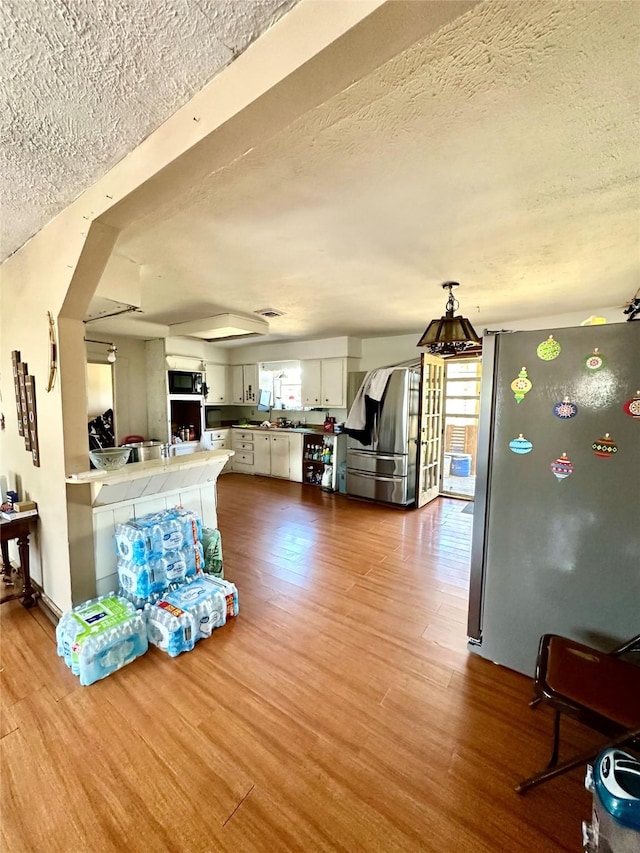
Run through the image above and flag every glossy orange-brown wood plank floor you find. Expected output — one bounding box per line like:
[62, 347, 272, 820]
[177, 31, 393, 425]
[0, 474, 590, 853]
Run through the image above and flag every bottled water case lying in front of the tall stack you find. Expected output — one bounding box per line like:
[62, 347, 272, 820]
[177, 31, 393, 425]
[147, 575, 227, 654]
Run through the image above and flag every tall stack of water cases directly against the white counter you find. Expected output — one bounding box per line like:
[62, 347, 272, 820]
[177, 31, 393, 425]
[115, 507, 204, 607]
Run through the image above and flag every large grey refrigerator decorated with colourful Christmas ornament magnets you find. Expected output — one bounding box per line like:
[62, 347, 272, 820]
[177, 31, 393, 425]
[468, 322, 640, 674]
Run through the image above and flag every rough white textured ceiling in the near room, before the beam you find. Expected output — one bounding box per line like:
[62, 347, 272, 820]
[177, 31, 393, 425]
[0, 0, 297, 259]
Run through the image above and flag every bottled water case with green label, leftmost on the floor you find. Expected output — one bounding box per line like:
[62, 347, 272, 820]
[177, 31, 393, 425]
[56, 595, 148, 686]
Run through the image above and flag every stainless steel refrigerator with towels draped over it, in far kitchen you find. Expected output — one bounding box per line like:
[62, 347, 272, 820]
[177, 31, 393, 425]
[347, 368, 420, 506]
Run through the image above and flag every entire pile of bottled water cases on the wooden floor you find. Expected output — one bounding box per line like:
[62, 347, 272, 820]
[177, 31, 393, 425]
[56, 507, 238, 685]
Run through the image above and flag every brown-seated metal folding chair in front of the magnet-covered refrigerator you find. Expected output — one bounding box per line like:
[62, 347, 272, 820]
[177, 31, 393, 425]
[516, 634, 640, 794]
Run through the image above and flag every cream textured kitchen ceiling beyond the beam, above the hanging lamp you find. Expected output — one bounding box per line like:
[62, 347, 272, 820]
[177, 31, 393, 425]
[99, 2, 640, 339]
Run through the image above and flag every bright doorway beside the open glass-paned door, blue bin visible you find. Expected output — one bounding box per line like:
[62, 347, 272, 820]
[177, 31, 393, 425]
[441, 358, 482, 500]
